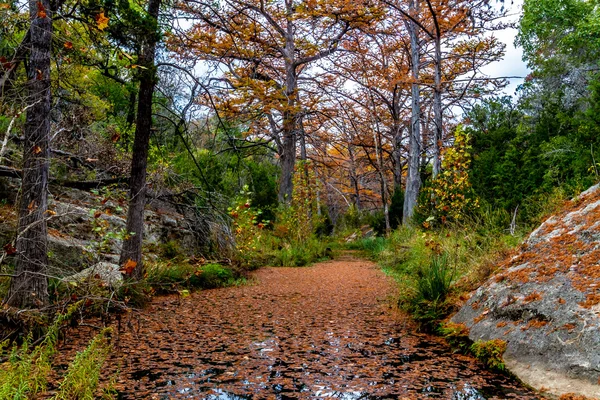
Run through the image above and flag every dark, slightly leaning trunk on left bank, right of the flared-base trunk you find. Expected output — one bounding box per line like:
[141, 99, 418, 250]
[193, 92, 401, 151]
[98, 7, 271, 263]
[119, 0, 161, 279]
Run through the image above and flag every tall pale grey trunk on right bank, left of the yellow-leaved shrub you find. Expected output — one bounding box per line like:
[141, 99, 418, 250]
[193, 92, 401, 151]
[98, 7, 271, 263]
[402, 0, 421, 224]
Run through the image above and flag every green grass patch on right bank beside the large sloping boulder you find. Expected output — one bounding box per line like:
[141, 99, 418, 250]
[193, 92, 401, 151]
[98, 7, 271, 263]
[346, 208, 526, 330]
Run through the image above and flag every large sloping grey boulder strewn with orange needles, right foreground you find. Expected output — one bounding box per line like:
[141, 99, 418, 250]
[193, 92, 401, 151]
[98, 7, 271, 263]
[453, 186, 600, 397]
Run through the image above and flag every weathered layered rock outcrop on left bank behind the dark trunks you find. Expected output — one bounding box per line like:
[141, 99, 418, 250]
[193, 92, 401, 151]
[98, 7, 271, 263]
[0, 178, 225, 277]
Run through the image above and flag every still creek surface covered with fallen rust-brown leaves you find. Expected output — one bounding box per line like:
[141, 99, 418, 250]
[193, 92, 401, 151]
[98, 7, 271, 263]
[50, 255, 540, 400]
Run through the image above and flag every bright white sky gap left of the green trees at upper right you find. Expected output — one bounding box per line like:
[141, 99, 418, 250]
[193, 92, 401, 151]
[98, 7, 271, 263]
[482, 0, 530, 95]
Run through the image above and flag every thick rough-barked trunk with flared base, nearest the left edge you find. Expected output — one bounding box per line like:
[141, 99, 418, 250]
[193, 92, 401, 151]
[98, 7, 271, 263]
[6, 0, 52, 308]
